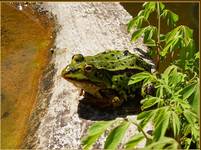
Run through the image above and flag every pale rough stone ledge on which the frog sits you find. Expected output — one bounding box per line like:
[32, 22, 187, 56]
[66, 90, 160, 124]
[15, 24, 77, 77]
[23, 2, 152, 149]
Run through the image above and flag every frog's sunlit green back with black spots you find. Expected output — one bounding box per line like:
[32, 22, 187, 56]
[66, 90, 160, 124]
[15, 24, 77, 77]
[86, 50, 151, 71]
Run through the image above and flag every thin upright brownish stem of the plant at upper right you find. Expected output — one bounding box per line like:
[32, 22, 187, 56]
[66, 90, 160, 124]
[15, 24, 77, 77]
[156, 2, 161, 70]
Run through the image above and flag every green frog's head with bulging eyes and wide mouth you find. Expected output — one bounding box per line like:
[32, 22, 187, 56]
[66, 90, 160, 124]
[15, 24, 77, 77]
[62, 54, 109, 96]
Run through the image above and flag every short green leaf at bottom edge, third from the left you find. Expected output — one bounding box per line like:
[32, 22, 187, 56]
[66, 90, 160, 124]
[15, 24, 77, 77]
[125, 133, 144, 149]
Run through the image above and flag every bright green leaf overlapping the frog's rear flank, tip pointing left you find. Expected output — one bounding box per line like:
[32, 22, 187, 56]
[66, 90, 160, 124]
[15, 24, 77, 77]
[128, 71, 151, 85]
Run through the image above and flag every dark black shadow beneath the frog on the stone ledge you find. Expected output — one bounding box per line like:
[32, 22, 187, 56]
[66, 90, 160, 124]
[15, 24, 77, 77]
[78, 98, 141, 121]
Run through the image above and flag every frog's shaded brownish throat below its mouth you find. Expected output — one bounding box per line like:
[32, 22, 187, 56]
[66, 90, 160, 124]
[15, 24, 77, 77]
[66, 78, 103, 99]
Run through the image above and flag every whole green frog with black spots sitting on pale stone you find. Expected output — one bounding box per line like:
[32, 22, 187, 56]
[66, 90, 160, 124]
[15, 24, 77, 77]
[61, 50, 151, 108]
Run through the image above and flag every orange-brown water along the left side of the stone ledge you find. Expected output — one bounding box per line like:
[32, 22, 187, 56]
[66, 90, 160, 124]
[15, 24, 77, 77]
[1, 3, 54, 149]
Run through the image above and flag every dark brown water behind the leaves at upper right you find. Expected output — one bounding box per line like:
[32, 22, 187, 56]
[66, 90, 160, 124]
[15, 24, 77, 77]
[121, 2, 199, 70]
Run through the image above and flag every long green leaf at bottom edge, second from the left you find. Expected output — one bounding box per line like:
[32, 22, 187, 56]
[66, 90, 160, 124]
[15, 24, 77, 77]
[104, 121, 130, 149]
